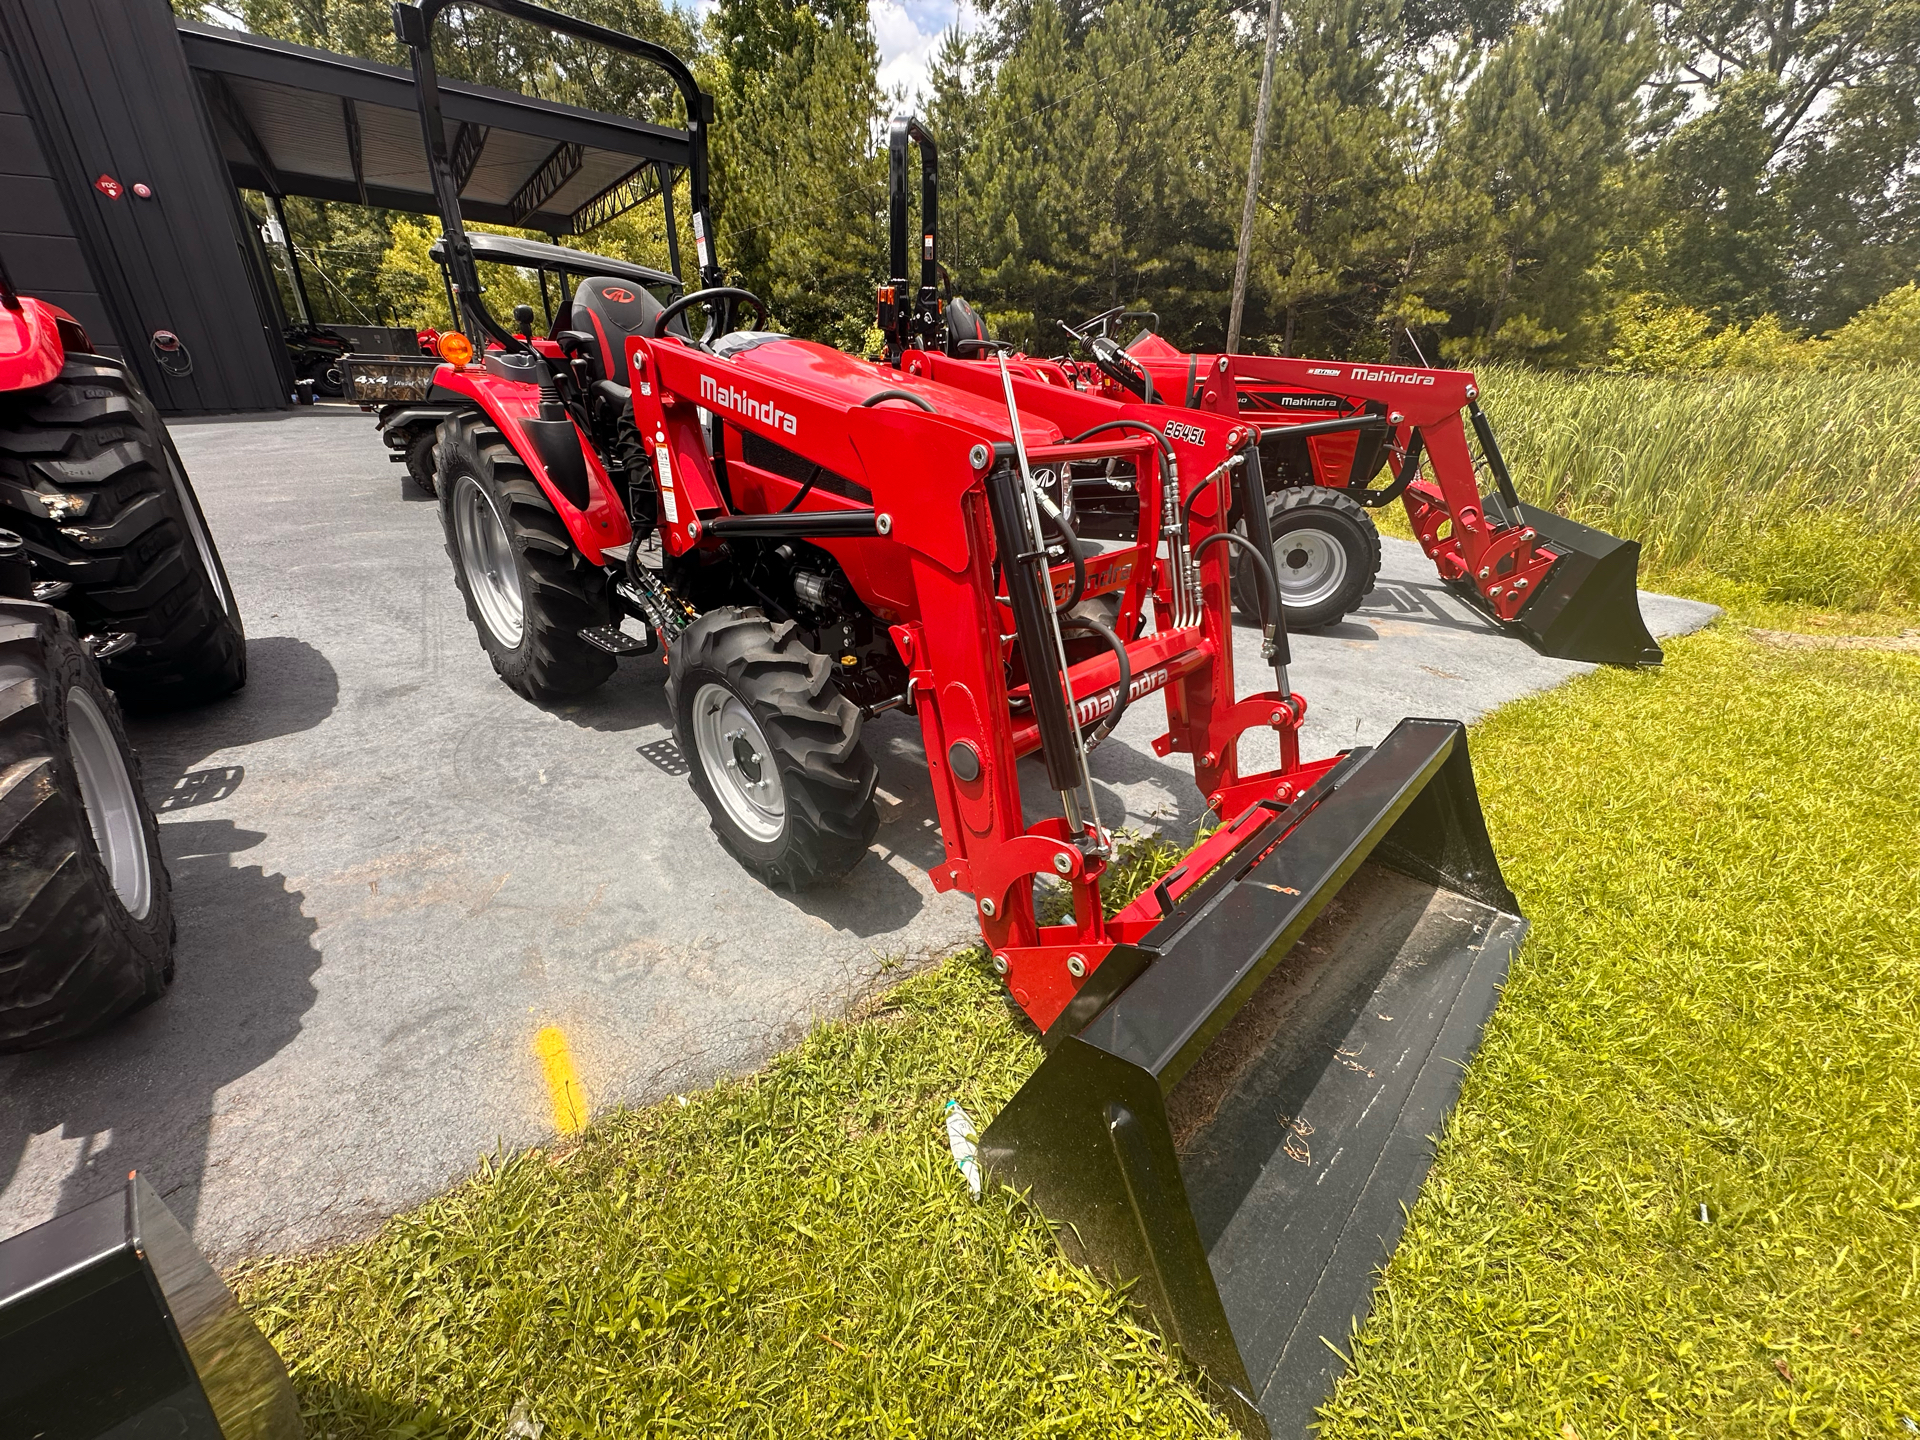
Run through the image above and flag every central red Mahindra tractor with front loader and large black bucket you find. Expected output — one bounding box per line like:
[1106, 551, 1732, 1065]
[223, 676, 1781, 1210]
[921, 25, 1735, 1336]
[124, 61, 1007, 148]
[394, 0, 1524, 1434]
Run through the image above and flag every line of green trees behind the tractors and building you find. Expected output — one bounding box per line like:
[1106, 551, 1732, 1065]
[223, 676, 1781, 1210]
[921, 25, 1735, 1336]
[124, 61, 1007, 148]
[182, 0, 1920, 367]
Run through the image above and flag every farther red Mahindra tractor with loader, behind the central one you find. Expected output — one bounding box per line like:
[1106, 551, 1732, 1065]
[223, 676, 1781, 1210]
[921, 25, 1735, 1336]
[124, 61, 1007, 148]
[879, 115, 1661, 666]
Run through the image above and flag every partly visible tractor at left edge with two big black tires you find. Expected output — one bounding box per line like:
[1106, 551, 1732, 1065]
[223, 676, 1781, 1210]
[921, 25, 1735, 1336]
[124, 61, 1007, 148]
[0, 253, 246, 1050]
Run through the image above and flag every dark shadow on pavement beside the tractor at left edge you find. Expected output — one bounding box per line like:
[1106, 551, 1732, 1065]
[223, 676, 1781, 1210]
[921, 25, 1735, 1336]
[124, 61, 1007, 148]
[0, 637, 338, 1235]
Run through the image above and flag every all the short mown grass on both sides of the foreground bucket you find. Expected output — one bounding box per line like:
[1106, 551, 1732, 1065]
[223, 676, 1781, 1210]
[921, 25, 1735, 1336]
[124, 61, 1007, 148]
[236, 628, 1920, 1440]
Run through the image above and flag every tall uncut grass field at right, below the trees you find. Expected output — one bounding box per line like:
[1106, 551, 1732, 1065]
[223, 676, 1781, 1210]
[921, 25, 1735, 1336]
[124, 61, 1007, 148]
[1478, 367, 1920, 609]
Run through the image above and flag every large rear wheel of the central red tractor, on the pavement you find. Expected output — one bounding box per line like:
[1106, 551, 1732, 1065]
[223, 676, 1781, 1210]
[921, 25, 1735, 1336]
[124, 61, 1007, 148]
[434, 411, 616, 701]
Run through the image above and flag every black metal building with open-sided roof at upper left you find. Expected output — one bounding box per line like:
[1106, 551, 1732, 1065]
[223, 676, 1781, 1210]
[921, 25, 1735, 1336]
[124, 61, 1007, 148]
[0, 0, 687, 415]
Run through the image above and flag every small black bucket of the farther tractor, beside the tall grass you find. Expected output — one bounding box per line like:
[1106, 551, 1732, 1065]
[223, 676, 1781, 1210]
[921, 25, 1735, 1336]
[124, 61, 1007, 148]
[1455, 495, 1663, 666]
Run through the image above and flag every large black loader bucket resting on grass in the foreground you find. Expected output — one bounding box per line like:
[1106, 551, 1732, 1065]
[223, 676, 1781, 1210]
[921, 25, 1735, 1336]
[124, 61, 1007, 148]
[981, 720, 1526, 1436]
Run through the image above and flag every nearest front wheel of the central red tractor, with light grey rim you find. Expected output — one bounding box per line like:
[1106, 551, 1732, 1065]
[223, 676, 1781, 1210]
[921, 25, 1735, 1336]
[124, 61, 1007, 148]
[666, 605, 879, 891]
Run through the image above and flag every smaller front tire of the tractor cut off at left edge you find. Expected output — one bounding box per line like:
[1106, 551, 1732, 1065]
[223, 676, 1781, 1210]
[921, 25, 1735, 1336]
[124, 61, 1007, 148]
[0, 599, 173, 1052]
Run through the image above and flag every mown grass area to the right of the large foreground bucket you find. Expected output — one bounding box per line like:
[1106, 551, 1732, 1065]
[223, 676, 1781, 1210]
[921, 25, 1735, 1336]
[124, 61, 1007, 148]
[1329, 632, 1920, 1440]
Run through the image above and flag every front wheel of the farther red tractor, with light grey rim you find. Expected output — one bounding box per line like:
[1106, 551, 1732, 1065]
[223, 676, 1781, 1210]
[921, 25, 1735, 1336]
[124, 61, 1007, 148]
[1233, 486, 1380, 630]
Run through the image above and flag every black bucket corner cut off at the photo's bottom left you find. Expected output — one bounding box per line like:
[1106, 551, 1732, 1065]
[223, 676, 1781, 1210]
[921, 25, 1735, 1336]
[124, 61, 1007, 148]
[0, 1175, 301, 1440]
